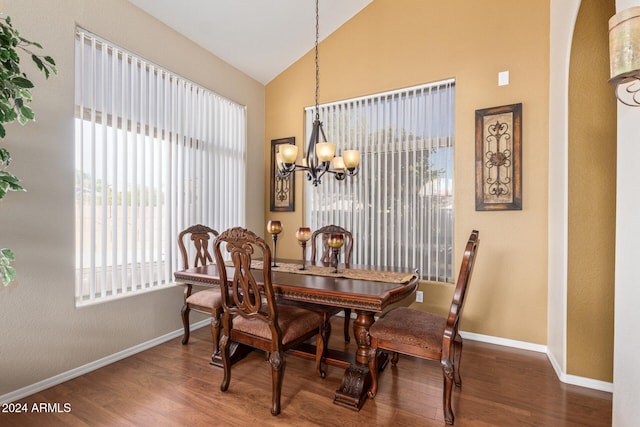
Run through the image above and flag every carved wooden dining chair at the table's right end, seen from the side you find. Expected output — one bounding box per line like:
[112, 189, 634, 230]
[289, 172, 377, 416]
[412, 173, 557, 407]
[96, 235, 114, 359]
[368, 230, 479, 424]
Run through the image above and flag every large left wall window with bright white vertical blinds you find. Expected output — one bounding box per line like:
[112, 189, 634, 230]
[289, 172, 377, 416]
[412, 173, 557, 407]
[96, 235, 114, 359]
[75, 29, 246, 305]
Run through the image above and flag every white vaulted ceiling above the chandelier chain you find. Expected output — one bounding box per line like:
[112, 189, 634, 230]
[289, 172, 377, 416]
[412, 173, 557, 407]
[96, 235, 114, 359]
[129, 0, 373, 84]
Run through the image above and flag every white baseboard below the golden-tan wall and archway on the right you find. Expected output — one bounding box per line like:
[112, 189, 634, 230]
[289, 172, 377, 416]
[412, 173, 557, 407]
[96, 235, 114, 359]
[460, 331, 613, 393]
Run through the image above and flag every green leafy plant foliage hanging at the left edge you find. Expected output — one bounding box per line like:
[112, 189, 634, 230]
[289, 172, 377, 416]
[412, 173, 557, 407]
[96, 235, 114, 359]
[0, 16, 57, 286]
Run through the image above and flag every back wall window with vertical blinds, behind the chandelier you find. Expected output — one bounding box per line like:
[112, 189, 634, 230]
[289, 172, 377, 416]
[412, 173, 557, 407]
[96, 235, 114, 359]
[306, 80, 455, 282]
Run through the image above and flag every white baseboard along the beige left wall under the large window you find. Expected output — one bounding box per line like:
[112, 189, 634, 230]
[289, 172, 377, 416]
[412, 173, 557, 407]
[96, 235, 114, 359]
[0, 319, 211, 405]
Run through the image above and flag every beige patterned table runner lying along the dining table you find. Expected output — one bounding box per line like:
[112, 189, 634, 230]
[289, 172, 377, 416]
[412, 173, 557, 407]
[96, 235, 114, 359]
[225, 260, 416, 283]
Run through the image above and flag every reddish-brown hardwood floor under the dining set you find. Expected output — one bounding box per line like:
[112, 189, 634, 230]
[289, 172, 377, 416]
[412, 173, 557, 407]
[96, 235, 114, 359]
[0, 318, 611, 427]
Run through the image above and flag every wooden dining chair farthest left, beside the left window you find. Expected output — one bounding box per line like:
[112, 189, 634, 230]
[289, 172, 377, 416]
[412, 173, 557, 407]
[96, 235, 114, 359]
[178, 224, 222, 354]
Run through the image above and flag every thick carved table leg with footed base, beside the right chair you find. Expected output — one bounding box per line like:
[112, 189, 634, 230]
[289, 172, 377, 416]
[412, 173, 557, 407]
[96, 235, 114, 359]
[333, 310, 384, 411]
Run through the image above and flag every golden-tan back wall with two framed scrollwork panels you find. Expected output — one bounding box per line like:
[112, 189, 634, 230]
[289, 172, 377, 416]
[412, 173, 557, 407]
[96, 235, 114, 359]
[263, 0, 549, 344]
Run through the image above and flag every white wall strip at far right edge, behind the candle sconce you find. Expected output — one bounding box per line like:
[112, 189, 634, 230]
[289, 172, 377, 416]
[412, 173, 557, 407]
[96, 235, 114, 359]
[612, 0, 640, 427]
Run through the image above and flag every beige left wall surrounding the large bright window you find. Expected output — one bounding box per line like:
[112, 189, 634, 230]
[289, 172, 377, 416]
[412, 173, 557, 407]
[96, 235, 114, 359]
[0, 0, 265, 396]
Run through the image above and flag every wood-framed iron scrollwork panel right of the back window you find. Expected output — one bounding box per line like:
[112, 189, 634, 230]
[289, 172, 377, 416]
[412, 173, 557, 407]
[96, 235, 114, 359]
[475, 103, 522, 211]
